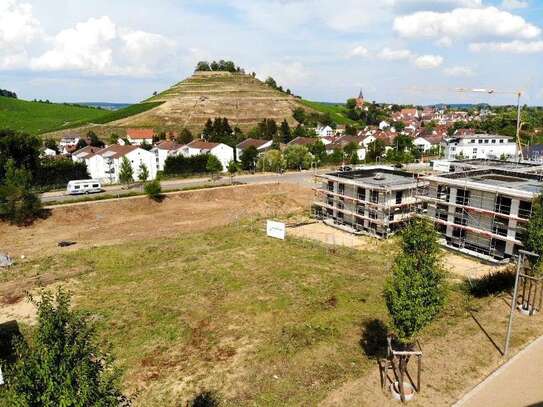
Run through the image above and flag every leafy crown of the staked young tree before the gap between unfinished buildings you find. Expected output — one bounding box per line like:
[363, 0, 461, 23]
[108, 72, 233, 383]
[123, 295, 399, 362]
[384, 219, 446, 345]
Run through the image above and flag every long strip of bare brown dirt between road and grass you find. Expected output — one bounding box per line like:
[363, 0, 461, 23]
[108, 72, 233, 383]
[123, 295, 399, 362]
[0, 184, 312, 259]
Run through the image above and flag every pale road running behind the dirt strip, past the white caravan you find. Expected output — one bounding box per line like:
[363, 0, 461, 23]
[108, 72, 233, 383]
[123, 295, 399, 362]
[41, 171, 314, 202]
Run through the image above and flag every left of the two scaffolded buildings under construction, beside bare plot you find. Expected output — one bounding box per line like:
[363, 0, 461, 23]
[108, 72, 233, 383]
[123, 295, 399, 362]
[313, 167, 427, 238]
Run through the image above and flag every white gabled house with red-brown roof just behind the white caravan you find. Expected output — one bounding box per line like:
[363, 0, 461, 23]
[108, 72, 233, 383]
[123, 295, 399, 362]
[72, 144, 157, 184]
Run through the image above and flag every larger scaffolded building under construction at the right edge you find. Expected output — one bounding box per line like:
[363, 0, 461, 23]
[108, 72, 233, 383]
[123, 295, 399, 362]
[421, 167, 543, 260]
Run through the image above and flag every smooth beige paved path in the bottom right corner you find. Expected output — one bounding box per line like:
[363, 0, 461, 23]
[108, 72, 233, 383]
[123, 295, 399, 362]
[454, 337, 543, 407]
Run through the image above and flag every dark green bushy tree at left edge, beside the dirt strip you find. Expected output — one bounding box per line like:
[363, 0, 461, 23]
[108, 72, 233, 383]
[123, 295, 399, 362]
[0, 159, 42, 225]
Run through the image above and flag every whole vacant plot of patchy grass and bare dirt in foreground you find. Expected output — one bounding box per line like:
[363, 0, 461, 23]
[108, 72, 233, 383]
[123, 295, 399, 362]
[0, 185, 543, 406]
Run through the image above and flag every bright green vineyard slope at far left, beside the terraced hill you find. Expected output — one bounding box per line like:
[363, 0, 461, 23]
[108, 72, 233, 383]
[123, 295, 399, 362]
[0, 96, 111, 134]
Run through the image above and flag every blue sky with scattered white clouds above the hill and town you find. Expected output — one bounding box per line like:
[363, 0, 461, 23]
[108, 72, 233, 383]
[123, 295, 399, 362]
[0, 0, 543, 105]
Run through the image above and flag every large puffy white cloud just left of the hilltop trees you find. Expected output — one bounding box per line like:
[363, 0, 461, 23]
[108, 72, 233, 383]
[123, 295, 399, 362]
[31, 16, 173, 76]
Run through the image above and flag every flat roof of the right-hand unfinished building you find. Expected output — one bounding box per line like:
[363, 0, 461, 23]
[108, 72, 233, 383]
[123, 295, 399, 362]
[426, 168, 543, 196]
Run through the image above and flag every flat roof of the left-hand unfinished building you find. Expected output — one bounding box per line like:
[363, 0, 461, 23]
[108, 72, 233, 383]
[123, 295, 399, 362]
[326, 168, 417, 188]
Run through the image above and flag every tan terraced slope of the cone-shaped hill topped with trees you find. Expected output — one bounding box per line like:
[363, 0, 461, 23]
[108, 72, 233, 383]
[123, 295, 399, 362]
[103, 72, 311, 131]
